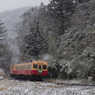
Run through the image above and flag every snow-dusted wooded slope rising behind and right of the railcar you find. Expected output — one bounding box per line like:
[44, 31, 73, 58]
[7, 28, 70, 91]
[0, 0, 95, 79]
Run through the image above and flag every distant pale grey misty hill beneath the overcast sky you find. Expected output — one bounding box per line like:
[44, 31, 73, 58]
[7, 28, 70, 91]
[0, 7, 30, 39]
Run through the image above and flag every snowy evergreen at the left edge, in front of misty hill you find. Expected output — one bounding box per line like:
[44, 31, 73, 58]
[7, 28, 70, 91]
[0, 20, 11, 70]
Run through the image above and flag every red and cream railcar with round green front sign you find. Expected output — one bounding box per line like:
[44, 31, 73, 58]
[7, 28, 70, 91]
[10, 61, 48, 79]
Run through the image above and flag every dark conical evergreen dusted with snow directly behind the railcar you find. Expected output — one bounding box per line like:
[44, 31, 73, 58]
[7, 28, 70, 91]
[22, 22, 46, 56]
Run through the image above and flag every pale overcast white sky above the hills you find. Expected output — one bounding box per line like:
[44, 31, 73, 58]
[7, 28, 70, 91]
[0, 0, 49, 12]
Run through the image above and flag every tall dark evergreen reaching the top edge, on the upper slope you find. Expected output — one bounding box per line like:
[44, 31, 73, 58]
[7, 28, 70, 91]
[47, 0, 75, 34]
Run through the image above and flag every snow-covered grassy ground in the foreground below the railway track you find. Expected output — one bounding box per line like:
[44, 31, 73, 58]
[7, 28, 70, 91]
[0, 79, 95, 95]
